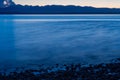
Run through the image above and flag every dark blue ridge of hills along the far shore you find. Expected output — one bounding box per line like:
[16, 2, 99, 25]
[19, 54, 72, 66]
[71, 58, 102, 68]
[0, 5, 120, 14]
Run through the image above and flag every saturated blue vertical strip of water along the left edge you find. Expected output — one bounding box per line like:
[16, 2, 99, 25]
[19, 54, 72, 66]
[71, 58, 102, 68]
[0, 15, 15, 61]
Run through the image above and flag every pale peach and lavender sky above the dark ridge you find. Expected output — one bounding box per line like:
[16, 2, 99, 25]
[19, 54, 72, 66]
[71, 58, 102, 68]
[13, 0, 120, 8]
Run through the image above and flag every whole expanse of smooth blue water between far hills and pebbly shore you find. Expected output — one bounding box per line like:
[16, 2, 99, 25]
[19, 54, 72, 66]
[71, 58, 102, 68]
[0, 15, 120, 64]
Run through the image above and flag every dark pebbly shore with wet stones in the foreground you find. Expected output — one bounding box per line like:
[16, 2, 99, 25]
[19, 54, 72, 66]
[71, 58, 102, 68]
[0, 59, 120, 80]
